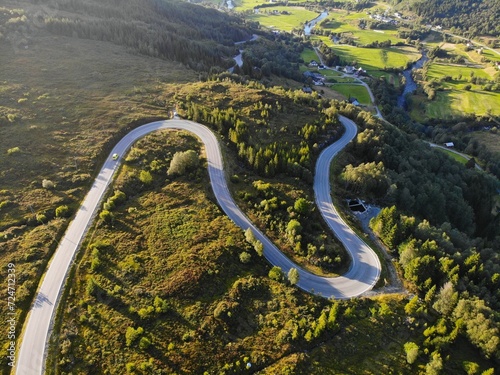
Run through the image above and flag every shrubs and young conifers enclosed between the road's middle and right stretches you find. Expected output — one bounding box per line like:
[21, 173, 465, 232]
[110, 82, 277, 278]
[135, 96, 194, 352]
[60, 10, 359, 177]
[165, 77, 348, 273]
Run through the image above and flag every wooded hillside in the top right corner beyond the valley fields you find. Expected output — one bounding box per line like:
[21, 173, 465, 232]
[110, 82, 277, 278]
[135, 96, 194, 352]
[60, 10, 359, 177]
[386, 0, 500, 37]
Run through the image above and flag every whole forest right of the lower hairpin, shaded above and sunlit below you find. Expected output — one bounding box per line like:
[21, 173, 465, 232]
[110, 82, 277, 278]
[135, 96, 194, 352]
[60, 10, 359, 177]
[334, 108, 500, 369]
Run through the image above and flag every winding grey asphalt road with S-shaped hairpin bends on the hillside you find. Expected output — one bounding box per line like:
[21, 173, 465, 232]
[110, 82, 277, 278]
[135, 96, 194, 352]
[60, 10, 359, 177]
[16, 117, 380, 375]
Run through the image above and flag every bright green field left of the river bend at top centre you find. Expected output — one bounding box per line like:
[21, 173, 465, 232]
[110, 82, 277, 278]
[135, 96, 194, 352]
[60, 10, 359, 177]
[246, 6, 319, 32]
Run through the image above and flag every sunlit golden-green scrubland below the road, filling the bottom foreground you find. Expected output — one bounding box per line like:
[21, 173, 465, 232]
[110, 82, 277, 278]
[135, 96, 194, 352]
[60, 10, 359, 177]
[48, 131, 495, 374]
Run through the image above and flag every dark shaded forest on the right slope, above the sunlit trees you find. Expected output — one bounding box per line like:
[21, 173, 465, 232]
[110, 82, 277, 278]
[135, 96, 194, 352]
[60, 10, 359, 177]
[344, 110, 498, 238]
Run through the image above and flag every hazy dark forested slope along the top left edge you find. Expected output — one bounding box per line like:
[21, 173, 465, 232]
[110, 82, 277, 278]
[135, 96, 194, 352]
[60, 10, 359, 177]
[39, 0, 252, 71]
